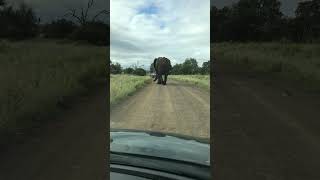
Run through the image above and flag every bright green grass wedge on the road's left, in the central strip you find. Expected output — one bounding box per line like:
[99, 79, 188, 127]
[110, 75, 151, 105]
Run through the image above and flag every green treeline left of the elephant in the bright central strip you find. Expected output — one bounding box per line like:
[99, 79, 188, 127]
[110, 60, 147, 76]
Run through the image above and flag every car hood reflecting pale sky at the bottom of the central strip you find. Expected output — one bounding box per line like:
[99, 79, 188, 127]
[110, 129, 210, 166]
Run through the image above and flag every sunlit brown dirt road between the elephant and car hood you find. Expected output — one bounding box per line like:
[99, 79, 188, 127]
[110, 80, 210, 137]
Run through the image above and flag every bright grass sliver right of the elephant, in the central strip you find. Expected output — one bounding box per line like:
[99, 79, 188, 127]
[169, 75, 210, 91]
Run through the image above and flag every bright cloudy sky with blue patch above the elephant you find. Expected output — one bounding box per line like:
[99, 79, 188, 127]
[110, 0, 210, 69]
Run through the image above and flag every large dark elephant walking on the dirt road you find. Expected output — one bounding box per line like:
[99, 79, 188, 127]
[153, 57, 172, 85]
